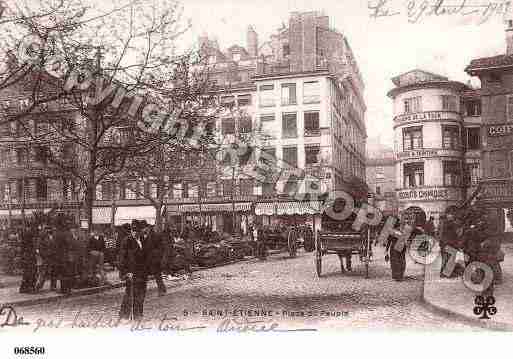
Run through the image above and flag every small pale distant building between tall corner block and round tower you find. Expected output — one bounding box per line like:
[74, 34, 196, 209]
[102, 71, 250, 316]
[365, 146, 398, 215]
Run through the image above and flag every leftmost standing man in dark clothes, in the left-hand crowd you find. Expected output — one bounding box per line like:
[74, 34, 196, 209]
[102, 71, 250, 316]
[20, 223, 37, 293]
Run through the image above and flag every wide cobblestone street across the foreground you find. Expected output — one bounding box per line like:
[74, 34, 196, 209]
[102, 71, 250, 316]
[5, 248, 484, 332]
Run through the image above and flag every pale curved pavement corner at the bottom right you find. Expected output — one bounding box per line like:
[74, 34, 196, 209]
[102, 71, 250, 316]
[423, 243, 513, 331]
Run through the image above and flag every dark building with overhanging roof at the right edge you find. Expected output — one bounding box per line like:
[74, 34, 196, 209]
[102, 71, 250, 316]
[465, 20, 513, 233]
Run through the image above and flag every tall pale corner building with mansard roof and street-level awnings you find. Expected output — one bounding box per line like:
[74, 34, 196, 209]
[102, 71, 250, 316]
[162, 12, 367, 230]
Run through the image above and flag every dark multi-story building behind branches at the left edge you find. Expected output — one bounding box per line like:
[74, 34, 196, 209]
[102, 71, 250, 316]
[0, 81, 79, 229]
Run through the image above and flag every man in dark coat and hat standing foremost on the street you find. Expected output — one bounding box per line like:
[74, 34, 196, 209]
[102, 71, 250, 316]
[119, 220, 151, 320]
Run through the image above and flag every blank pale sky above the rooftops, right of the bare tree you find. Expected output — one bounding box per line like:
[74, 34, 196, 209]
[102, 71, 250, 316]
[178, 0, 511, 145]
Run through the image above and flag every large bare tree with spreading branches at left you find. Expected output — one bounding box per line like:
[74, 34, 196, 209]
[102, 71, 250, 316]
[0, 0, 203, 226]
